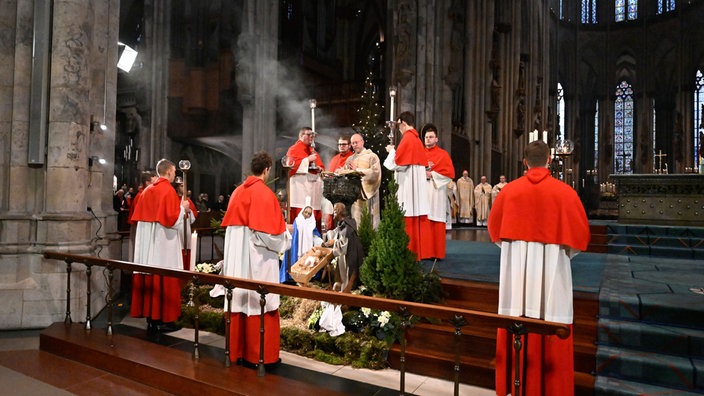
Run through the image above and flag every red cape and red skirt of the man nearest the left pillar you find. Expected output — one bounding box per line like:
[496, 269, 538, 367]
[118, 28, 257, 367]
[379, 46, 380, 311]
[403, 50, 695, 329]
[130, 178, 181, 323]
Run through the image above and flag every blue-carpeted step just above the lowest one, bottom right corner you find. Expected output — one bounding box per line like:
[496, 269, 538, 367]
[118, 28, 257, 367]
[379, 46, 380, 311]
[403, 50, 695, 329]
[596, 346, 704, 394]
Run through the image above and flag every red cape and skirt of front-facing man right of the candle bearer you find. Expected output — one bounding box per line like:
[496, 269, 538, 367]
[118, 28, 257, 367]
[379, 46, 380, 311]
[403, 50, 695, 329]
[422, 146, 455, 259]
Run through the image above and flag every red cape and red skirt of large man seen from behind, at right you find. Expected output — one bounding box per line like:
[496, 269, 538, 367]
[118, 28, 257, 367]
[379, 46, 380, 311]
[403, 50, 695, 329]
[488, 168, 590, 396]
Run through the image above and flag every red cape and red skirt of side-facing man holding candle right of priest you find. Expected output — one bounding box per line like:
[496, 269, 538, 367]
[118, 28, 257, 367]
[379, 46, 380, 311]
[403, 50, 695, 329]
[394, 128, 430, 260]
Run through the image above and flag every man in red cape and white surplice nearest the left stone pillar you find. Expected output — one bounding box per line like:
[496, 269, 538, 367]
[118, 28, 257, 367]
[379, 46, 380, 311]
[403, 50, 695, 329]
[130, 159, 190, 332]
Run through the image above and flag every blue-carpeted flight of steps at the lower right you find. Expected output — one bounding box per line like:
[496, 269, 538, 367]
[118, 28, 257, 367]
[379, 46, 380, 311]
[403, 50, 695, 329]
[595, 226, 704, 395]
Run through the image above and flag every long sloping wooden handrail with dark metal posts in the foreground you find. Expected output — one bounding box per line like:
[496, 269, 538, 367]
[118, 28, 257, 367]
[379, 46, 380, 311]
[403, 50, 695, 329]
[44, 251, 570, 395]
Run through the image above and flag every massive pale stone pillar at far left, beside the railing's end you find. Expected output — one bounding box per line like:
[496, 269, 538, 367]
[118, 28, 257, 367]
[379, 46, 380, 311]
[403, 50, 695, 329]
[0, 0, 119, 329]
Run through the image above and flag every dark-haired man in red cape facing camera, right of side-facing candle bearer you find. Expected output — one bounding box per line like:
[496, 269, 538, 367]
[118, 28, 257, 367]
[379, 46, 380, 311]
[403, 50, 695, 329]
[422, 124, 455, 259]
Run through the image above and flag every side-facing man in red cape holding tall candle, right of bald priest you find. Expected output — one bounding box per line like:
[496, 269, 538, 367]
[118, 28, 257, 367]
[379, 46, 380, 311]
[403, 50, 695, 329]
[384, 111, 430, 260]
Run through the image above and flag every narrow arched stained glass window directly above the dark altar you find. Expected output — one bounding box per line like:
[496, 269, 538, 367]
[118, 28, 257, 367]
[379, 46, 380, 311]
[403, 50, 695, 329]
[614, 81, 634, 174]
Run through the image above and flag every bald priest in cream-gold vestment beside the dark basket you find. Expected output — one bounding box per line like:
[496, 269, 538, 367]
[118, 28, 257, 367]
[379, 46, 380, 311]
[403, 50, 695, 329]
[345, 133, 381, 230]
